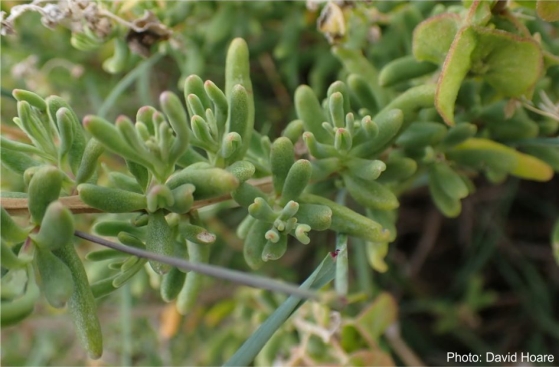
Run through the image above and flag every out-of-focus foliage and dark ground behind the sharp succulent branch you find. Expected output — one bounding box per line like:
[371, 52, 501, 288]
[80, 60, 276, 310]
[0, 0, 559, 366]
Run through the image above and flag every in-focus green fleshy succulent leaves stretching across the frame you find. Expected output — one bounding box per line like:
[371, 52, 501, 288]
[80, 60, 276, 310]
[1, 1, 559, 357]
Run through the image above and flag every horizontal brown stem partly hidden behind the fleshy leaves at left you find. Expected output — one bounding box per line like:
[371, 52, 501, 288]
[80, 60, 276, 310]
[0, 177, 272, 215]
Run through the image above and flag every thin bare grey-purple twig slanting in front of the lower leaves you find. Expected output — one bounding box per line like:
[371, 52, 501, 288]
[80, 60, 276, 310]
[74, 231, 318, 300]
